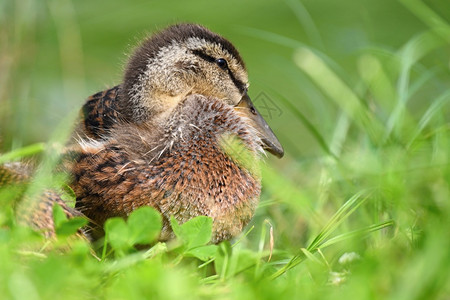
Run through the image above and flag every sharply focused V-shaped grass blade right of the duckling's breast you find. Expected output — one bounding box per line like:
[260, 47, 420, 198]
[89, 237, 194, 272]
[270, 191, 393, 279]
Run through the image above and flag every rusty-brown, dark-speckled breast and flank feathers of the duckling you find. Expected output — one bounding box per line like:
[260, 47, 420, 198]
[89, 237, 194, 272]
[72, 138, 261, 242]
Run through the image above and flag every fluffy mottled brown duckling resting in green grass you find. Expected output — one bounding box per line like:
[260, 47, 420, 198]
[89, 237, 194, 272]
[66, 24, 283, 242]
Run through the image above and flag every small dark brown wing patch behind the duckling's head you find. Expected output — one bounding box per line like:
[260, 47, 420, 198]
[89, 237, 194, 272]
[75, 85, 121, 140]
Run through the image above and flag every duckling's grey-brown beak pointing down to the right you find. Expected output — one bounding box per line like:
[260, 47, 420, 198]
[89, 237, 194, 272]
[235, 93, 284, 158]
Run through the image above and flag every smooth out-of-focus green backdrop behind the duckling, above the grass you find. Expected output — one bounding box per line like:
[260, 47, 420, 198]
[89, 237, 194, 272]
[0, 0, 450, 157]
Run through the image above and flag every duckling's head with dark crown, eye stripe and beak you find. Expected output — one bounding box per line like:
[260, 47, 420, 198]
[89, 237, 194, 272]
[122, 24, 283, 157]
